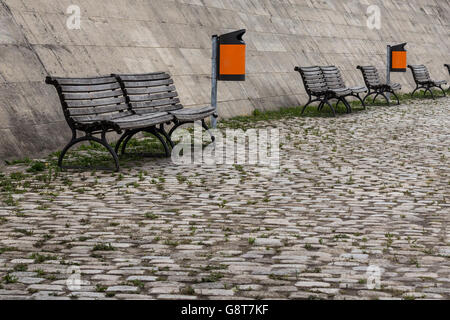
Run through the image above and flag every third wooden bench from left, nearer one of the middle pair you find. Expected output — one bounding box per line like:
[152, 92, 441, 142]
[294, 66, 352, 116]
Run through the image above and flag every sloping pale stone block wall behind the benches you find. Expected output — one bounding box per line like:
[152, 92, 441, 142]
[0, 0, 450, 159]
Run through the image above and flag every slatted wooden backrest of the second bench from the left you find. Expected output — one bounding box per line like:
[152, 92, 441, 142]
[113, 72, 183, 114]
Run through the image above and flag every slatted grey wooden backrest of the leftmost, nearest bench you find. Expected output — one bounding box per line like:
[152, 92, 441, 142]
[45, 76, 131, 128]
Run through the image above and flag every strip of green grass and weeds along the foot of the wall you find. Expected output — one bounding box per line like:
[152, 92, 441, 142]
[0, 89, 450, 179]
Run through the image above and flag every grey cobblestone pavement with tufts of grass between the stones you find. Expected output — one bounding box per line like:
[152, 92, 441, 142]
[0, 98, 450, 299]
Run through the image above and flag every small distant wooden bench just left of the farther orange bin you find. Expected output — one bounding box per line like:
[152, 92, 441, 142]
[356, 66, 402, 105]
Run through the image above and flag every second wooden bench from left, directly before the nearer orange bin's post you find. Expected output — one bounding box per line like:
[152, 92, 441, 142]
[113, 72, 217, 153]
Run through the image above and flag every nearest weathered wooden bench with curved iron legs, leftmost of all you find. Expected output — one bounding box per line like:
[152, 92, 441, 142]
[45, 76, 174, 171]
